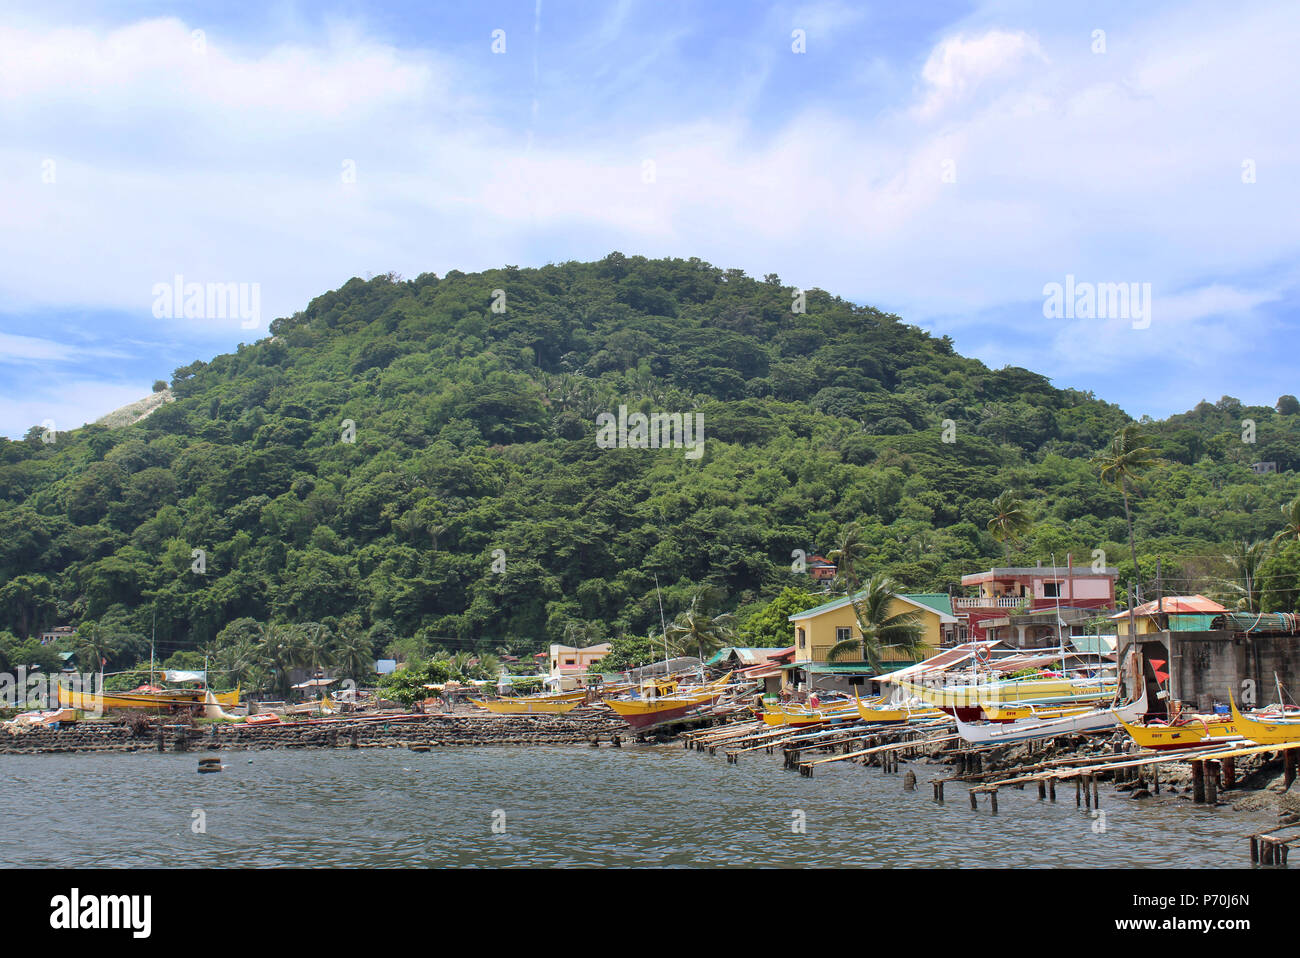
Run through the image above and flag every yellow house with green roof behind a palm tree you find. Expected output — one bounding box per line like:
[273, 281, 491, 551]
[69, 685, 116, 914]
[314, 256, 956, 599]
[783, 593, 957, 692]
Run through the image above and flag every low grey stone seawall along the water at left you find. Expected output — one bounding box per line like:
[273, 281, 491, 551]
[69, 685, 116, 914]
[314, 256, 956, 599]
[0, 715, 629, 755]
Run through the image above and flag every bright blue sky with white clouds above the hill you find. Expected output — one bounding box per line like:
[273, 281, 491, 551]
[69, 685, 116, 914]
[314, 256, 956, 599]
[0, 0, 1300, 437]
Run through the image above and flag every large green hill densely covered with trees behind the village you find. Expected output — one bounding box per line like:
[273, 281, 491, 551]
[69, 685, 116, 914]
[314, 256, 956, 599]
[0, 253, 1300, 654]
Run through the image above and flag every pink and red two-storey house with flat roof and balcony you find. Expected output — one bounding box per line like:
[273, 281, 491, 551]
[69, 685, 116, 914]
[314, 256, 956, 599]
[953, 556, 1119, 645]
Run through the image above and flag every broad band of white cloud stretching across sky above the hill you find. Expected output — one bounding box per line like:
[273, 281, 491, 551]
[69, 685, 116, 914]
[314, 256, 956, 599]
[0, 4, 1300, 421]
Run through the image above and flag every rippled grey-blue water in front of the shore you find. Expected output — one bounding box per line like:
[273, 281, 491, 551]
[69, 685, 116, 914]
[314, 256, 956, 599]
[0, 746, 1274, 867]
